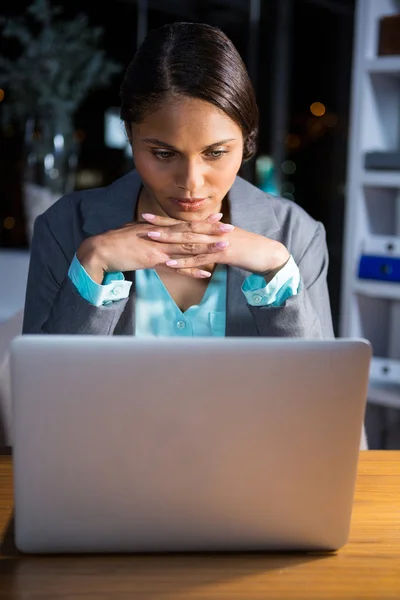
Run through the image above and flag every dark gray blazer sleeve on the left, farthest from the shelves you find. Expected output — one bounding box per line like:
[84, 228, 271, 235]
[22, 214, 128, 335]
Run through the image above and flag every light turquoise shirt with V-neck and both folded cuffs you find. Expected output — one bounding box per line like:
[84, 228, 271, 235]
[68, 255, 300, 337]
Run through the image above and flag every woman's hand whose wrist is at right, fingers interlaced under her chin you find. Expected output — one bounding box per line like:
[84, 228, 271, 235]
[142, 217, 290, 280]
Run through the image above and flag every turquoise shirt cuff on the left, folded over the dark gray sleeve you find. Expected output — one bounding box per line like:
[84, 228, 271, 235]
[68, 254, 132, 306]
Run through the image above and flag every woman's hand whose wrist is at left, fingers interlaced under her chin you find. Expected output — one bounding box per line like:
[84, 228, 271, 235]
[77, 213, 226, 284]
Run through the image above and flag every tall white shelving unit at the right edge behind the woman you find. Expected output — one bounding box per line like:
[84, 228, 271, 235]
[340, 0, 400, 434]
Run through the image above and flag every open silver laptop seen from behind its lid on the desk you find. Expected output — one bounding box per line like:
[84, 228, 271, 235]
[11, 335, 371, 554]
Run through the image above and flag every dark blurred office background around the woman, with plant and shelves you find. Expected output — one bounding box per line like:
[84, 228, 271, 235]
[0, 0, 400, 447]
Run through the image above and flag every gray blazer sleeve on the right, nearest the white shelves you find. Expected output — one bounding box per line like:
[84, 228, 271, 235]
[249, 223, 334, 338]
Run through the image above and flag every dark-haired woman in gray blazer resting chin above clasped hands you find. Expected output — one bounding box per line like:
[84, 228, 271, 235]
[23, 23, 333, 338]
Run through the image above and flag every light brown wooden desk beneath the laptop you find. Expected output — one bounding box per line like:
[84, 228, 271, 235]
[0, 451, 400, 600]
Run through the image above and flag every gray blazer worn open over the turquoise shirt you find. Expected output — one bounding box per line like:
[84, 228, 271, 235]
[23, 171, 333, 338]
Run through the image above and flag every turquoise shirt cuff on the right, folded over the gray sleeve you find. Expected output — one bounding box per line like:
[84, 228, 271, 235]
[242, 256, 300, 306]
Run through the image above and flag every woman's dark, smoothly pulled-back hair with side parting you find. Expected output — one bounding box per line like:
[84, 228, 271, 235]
[120, 23, 258, 161]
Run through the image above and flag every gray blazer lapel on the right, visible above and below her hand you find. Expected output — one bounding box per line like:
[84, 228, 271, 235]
[226, 177, 280, 337]
